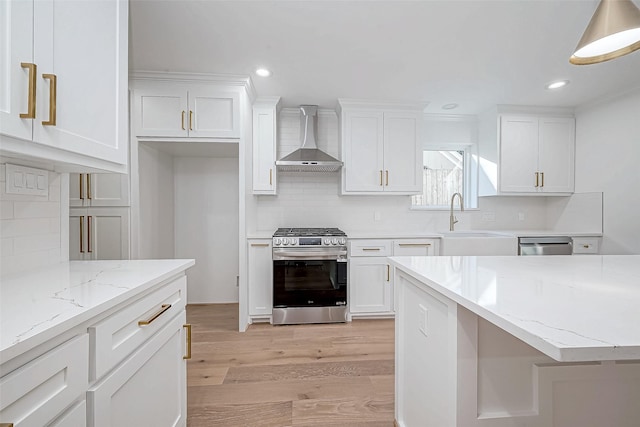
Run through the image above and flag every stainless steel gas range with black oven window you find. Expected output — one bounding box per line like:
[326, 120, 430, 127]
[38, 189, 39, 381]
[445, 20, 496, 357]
[272, 228, 348, 325]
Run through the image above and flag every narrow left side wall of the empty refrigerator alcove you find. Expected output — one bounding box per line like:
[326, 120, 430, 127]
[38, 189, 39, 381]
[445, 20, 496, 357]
[138, 144, 175, 259]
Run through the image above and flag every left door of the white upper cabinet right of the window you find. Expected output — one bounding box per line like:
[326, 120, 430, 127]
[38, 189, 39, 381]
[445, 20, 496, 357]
[500, 116, 539, 193]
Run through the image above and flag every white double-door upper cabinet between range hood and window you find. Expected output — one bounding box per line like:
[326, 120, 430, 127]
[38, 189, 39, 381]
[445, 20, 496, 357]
[338, 100, 422, 194]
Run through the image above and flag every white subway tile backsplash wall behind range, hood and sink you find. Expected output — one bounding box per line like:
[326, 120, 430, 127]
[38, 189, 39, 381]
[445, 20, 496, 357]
[248, 110, 546, 235]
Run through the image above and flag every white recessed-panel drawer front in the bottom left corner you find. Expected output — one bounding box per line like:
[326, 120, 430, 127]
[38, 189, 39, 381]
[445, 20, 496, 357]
[0, 334, 89, 427]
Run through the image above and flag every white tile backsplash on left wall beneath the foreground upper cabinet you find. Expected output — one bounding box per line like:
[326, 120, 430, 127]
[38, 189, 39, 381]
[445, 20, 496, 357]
[0, 163, 69, 276]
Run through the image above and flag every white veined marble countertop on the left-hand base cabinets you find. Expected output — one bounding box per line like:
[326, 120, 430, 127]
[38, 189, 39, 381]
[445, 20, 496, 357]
[0, 259, 195, 363]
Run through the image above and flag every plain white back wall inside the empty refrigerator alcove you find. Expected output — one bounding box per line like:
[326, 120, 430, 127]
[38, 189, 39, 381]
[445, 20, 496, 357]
[173, 157, 239, 303]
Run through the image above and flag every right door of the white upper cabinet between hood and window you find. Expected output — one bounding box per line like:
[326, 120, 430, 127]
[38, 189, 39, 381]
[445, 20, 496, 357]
[384, 113, 422, 193]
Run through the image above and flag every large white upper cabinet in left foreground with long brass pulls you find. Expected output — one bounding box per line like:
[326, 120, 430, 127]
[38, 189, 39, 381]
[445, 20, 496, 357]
[0, 0, 128, 172]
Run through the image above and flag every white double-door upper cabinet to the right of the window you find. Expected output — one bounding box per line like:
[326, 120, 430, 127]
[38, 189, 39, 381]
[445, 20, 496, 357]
[479, 109, 575, 196]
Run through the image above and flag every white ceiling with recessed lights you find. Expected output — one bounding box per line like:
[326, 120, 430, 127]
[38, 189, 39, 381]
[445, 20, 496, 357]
[130, 0, 640, 114]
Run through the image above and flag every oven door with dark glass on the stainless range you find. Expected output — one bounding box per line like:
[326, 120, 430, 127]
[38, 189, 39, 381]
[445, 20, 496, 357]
[273, 251, 348, 308]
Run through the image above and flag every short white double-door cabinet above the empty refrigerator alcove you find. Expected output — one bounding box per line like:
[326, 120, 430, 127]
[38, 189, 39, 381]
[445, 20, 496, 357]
[132, 81, 240, 139]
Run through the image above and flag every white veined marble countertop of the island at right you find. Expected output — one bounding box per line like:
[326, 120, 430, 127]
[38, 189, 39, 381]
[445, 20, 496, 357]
[390, 255, 640, 362]
